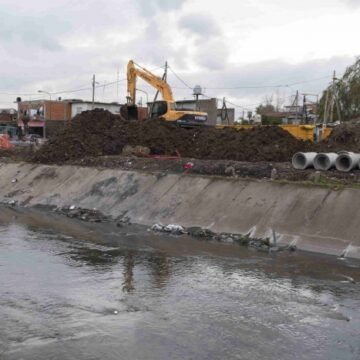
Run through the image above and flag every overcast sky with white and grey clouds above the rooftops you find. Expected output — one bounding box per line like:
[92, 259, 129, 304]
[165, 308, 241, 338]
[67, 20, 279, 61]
[0, 0, 360, 114]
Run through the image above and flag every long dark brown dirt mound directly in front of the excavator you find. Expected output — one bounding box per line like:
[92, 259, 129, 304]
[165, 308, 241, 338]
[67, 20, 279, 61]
[32, 109, 312, 163]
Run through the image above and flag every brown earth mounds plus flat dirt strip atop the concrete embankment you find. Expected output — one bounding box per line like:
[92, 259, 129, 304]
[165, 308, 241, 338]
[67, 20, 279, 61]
[0, 109, 360, 184]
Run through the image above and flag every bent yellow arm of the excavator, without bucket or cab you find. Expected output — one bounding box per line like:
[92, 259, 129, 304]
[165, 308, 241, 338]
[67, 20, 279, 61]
[127, 60, 174, 105]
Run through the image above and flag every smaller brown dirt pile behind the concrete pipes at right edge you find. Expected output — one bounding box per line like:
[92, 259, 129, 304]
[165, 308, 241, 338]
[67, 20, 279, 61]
[315, 123, 360, 152]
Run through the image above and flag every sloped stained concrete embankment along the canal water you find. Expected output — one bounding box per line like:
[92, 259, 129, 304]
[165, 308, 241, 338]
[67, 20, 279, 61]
[0, 163, 360, 258]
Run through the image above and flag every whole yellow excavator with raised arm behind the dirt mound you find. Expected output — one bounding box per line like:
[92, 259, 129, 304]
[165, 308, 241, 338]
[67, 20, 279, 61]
[120, 60, 208, 126]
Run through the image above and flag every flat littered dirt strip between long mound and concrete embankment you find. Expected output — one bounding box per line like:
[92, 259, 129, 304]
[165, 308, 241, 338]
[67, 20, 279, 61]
[0, 147, 360, 186]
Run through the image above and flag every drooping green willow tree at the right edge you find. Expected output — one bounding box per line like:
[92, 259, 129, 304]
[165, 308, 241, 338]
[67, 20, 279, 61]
[319, 57, 360, 121]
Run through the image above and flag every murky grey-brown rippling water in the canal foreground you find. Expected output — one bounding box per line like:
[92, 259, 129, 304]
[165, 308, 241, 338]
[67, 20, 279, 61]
[0, 208, 360, 360]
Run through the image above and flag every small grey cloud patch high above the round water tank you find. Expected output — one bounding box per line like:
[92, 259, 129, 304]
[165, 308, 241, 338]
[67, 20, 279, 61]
[179, 14, 221, 38]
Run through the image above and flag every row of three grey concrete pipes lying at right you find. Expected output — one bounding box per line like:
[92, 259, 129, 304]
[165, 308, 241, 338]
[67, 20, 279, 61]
[292, 151, 360, 172]
